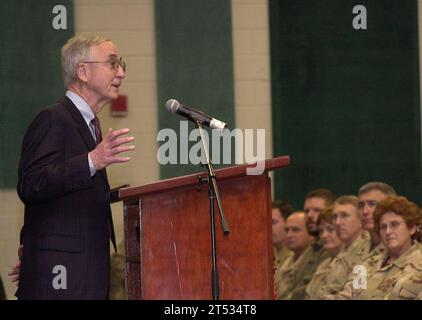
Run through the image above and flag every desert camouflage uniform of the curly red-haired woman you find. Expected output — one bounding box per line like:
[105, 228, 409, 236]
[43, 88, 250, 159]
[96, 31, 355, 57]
[336, 242, 422, 300]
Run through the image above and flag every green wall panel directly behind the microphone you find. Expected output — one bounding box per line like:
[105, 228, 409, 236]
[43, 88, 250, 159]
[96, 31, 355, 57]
[155, 0, 235, 178]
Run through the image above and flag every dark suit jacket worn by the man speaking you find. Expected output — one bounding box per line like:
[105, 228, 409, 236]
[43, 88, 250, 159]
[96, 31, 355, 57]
[16, 97, 115, 299]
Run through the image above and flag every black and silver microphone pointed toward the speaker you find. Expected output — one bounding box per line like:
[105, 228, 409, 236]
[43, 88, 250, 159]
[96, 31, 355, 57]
[166, 99, 227, 130]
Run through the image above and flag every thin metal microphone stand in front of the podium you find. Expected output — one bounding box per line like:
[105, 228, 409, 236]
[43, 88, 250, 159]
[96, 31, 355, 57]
[196, 121, 230, 300]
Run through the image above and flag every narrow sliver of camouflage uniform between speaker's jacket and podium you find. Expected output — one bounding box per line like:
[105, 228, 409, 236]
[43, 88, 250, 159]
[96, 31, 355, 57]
[109, 241, 127, 300]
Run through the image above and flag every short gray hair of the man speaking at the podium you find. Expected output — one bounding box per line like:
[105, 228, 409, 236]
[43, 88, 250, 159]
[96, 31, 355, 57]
[62, 35, 111, 88]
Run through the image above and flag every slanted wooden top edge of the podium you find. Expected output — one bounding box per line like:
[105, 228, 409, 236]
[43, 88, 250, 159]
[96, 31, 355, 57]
[119, 156, 290, 200]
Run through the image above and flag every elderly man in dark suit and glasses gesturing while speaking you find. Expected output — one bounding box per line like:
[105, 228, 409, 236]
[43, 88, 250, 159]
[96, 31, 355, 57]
[16, 36, 134, 299]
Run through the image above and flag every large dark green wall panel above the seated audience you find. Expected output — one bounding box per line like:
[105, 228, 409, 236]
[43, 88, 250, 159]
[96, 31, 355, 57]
[269, 0, 422, 208]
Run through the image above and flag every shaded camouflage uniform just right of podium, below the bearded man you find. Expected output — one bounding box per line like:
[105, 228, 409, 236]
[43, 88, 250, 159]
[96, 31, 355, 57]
[277, 243, 329, 300]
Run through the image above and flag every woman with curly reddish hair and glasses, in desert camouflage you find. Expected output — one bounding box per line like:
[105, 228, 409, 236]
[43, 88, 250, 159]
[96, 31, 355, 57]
[339, 196, 422, 300]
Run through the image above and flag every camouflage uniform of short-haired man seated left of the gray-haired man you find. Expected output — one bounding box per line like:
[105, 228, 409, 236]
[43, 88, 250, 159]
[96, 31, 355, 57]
[313, 231, 370, 299]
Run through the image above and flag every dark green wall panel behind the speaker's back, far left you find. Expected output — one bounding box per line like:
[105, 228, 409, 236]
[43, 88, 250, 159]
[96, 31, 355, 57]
[0, 0, 73, 188]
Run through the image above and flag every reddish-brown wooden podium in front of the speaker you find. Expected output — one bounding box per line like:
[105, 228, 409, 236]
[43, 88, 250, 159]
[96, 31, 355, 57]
[119, 156, 290, 300]
